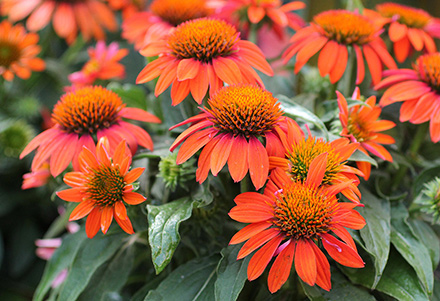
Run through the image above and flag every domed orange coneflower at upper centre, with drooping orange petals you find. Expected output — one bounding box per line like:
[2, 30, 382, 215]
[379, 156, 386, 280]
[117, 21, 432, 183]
[137, 18, 273, 105]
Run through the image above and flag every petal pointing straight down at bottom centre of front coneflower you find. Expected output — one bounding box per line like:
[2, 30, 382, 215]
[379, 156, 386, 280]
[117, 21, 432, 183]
[295, 239, 317, 286]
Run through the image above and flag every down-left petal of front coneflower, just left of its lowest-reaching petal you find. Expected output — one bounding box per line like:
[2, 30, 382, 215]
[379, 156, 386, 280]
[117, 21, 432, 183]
[247, 235, 284, 281]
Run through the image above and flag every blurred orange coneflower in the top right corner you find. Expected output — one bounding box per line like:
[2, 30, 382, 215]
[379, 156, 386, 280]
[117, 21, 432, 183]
[367, 2, 440, 62]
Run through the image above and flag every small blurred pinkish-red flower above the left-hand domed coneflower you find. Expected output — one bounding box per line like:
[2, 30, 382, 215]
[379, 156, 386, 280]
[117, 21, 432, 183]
[69, 41, 128, 87]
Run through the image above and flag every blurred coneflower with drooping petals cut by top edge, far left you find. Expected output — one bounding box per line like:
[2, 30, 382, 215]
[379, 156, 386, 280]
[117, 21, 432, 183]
[1, 0, 117, 43]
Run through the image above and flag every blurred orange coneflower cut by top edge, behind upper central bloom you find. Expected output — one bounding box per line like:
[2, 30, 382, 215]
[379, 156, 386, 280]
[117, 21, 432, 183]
[122, 0, 212, 50]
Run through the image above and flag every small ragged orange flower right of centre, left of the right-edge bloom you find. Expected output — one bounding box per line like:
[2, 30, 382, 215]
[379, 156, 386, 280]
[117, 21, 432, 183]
[336, 88, 396, 180]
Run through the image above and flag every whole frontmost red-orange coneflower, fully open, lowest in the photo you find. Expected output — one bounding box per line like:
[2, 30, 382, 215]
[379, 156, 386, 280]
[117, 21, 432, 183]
[229, 162, 365, 293]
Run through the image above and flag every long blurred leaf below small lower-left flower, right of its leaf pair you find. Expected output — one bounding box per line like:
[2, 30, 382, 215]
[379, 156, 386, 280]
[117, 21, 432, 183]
[58, 232, 128, 300]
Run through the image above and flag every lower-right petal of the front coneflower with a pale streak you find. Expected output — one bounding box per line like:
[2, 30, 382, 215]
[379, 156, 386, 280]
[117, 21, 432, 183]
[322, 234, 365, 268]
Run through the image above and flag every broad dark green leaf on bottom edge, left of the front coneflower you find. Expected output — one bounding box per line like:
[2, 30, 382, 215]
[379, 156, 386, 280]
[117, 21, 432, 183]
[145, 255, 220, 301]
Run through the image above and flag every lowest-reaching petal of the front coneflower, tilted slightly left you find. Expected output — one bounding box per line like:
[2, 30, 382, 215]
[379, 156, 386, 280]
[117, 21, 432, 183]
[267, 240, 295, 294]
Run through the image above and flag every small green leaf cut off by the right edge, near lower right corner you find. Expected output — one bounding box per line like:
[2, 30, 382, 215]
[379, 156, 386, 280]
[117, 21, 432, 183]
[408, 219, 440, 270]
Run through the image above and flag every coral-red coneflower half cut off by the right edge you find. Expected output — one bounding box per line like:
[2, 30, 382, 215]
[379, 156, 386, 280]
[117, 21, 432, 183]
[374, 52, 440, 142]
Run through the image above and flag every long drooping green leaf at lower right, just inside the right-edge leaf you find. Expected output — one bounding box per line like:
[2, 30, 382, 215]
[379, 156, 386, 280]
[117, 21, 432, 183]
[391, 204, 434, 294]
